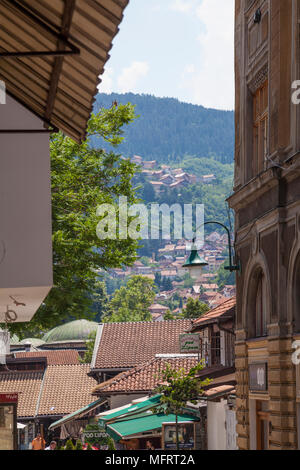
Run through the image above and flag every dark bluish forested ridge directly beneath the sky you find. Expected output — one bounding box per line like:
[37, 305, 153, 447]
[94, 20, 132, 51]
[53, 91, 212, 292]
[94, 93, 234, 163]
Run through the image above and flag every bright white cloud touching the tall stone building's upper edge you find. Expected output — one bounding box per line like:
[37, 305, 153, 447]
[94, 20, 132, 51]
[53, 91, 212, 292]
[181, 0, 234, 109]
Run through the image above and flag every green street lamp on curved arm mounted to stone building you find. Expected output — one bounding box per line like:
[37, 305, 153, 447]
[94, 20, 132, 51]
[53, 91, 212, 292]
[183, 221, 240, 279]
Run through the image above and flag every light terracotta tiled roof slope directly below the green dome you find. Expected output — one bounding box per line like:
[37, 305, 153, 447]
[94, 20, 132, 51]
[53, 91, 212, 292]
[38, 364, 96, 416]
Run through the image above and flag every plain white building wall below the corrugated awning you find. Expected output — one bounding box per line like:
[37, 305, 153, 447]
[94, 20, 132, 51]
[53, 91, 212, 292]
[0, 96, 52, 323]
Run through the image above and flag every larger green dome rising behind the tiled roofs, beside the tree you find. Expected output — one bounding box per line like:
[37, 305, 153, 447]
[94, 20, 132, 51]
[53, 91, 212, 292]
[43, 320, 98, 343]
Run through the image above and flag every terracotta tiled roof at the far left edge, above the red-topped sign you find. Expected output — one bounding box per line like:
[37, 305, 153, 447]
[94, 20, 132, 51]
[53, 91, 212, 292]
[0, 371, 44, 417]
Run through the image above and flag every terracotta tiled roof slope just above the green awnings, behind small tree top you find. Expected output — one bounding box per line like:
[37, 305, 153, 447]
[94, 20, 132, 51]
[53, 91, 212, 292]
[92, 357, 198, 395]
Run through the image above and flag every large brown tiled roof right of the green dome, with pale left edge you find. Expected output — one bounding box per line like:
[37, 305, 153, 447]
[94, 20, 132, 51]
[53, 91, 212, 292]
[91, 320, 192, 369]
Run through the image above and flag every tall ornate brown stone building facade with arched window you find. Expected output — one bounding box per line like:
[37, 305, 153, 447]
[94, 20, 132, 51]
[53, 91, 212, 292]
[229, 0, 300, 450]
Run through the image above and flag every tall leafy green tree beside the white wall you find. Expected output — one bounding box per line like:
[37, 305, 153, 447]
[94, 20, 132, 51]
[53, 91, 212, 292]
[12, 104, 137, 336]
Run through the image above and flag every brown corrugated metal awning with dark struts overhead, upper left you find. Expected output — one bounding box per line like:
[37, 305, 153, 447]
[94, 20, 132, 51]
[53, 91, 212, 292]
[0, 0, 129, 142]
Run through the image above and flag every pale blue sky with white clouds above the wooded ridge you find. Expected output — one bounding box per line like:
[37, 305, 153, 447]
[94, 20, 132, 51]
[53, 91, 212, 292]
[99, 0, 234, 110]
